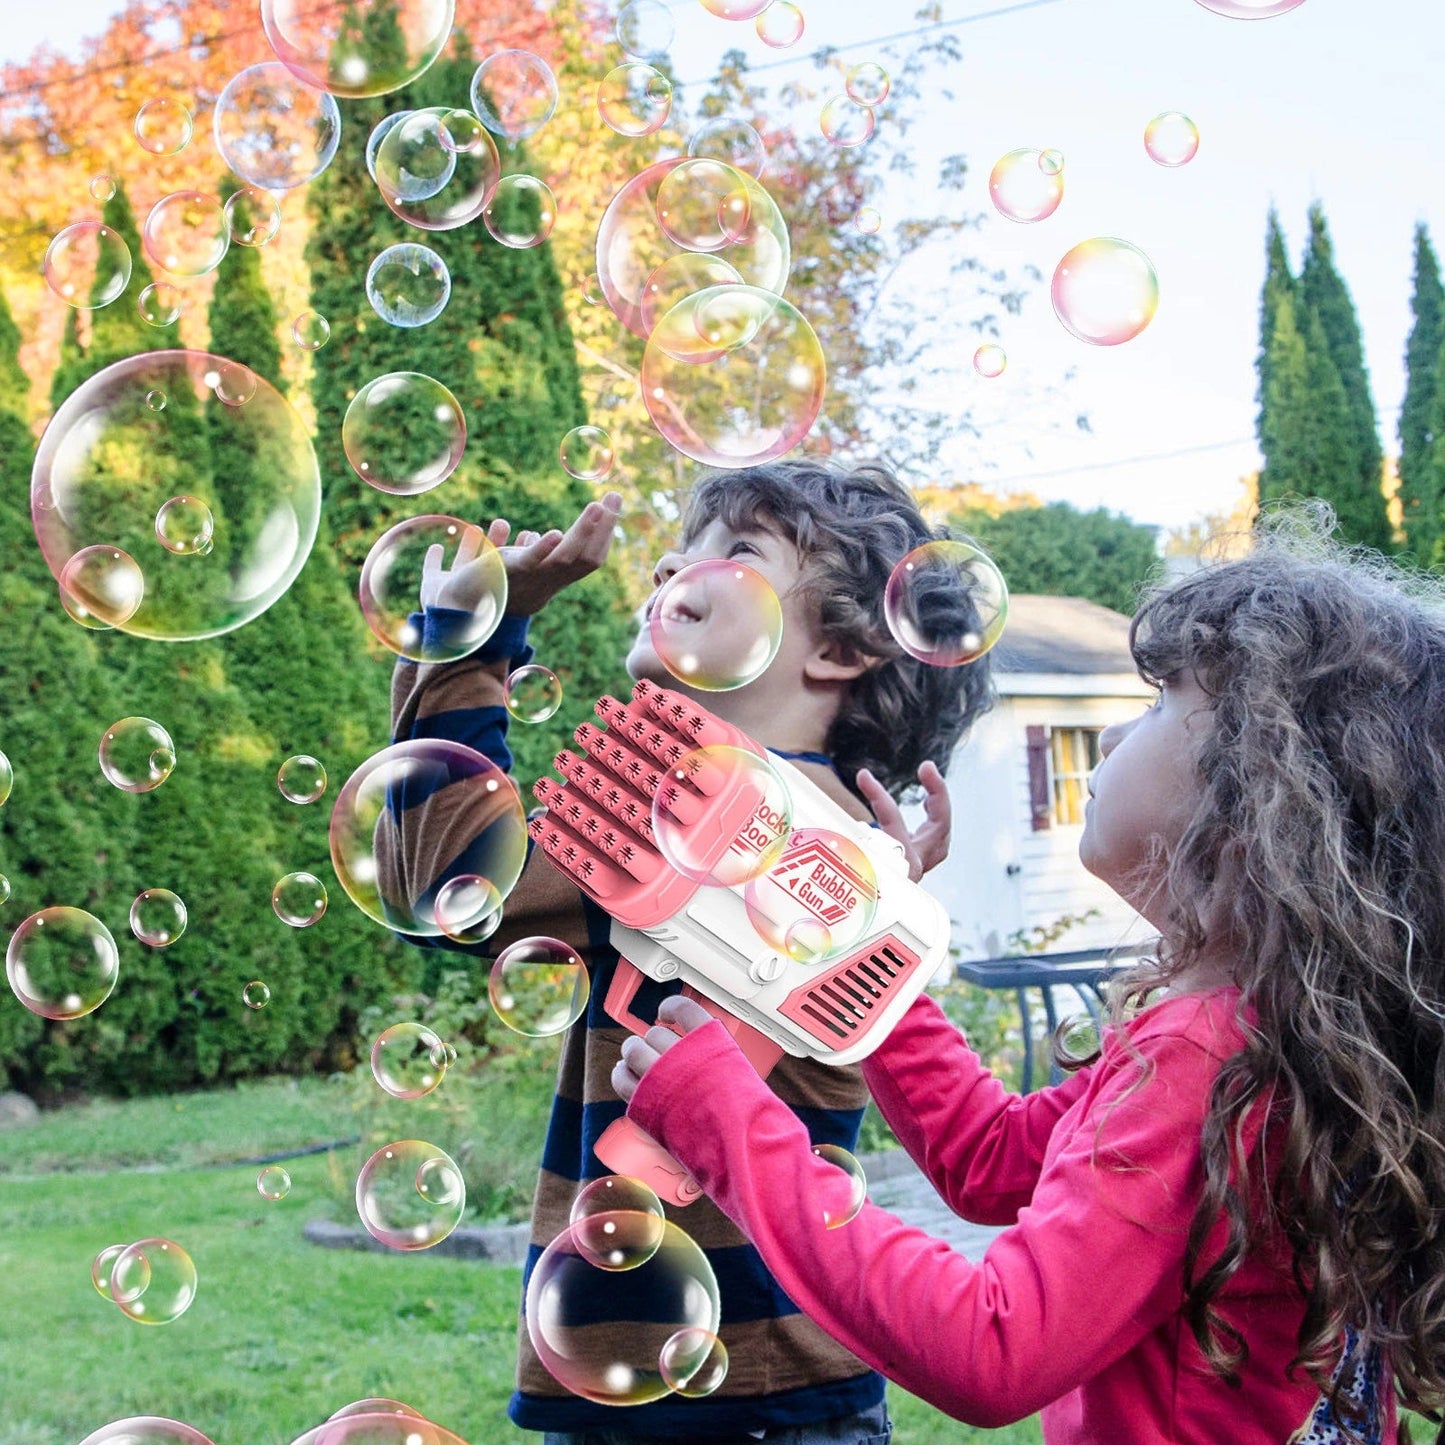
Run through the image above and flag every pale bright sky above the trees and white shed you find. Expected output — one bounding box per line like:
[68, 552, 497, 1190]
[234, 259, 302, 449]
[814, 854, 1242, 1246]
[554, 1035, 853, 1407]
[0, 0, 1445, 526]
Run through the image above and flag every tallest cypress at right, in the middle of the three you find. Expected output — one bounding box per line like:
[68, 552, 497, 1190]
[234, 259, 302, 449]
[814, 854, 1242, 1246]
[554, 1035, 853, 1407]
[1299, 202, 1392, 549]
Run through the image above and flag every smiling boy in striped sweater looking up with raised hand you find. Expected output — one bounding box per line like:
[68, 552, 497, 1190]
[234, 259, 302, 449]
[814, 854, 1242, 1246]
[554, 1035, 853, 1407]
[393, 460, 990, 1445]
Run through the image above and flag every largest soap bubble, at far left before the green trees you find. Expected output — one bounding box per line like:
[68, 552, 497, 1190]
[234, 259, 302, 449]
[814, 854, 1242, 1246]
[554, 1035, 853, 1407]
[30, 351, 321, 642]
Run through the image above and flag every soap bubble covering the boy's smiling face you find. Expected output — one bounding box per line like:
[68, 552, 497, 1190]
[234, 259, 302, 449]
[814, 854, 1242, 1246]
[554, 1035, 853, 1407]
[649, 558, 783, 692]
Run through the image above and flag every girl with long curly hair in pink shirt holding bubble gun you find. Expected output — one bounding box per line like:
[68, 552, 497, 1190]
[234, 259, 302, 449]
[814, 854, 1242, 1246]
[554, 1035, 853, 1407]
[613, 517, 1445, 1445]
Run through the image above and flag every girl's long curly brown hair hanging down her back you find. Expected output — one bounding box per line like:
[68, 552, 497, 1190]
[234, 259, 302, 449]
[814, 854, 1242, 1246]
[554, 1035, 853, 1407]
[1074, 504, 1445, 1439]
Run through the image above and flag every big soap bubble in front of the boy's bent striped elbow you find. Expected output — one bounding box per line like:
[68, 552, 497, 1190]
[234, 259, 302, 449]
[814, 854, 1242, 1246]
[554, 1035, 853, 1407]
[331, 738, 527, 936]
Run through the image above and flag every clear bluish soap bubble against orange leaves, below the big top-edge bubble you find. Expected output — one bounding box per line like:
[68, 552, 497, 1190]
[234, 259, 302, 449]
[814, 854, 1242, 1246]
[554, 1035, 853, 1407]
[214, 61, 341, 191]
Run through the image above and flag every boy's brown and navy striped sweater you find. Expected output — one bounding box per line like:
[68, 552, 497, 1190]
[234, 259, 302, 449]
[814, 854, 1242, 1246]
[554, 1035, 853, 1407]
[390, 613, 884, 1441]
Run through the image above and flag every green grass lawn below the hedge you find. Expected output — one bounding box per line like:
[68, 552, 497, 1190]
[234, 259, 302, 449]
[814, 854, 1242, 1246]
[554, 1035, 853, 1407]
[0, 1078, 1039, 1445]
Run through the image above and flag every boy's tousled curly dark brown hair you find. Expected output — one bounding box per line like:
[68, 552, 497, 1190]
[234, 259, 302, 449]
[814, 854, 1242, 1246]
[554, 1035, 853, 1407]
[682, 458, 993, 798]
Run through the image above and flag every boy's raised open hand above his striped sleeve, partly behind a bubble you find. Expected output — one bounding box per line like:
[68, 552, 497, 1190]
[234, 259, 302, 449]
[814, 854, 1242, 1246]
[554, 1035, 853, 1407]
[420, 491, 623, 617]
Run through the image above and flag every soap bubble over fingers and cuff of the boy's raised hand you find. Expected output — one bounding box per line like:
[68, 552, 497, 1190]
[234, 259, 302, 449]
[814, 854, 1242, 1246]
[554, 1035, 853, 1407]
[358, 514, 507, 662]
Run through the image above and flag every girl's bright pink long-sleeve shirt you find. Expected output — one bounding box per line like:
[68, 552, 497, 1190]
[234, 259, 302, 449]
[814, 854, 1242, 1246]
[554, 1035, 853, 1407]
[629, 988, 1394, 1445]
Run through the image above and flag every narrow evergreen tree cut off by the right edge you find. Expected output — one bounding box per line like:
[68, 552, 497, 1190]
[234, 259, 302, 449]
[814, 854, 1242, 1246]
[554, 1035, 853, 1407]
[1400, 224, 1445, 564]
